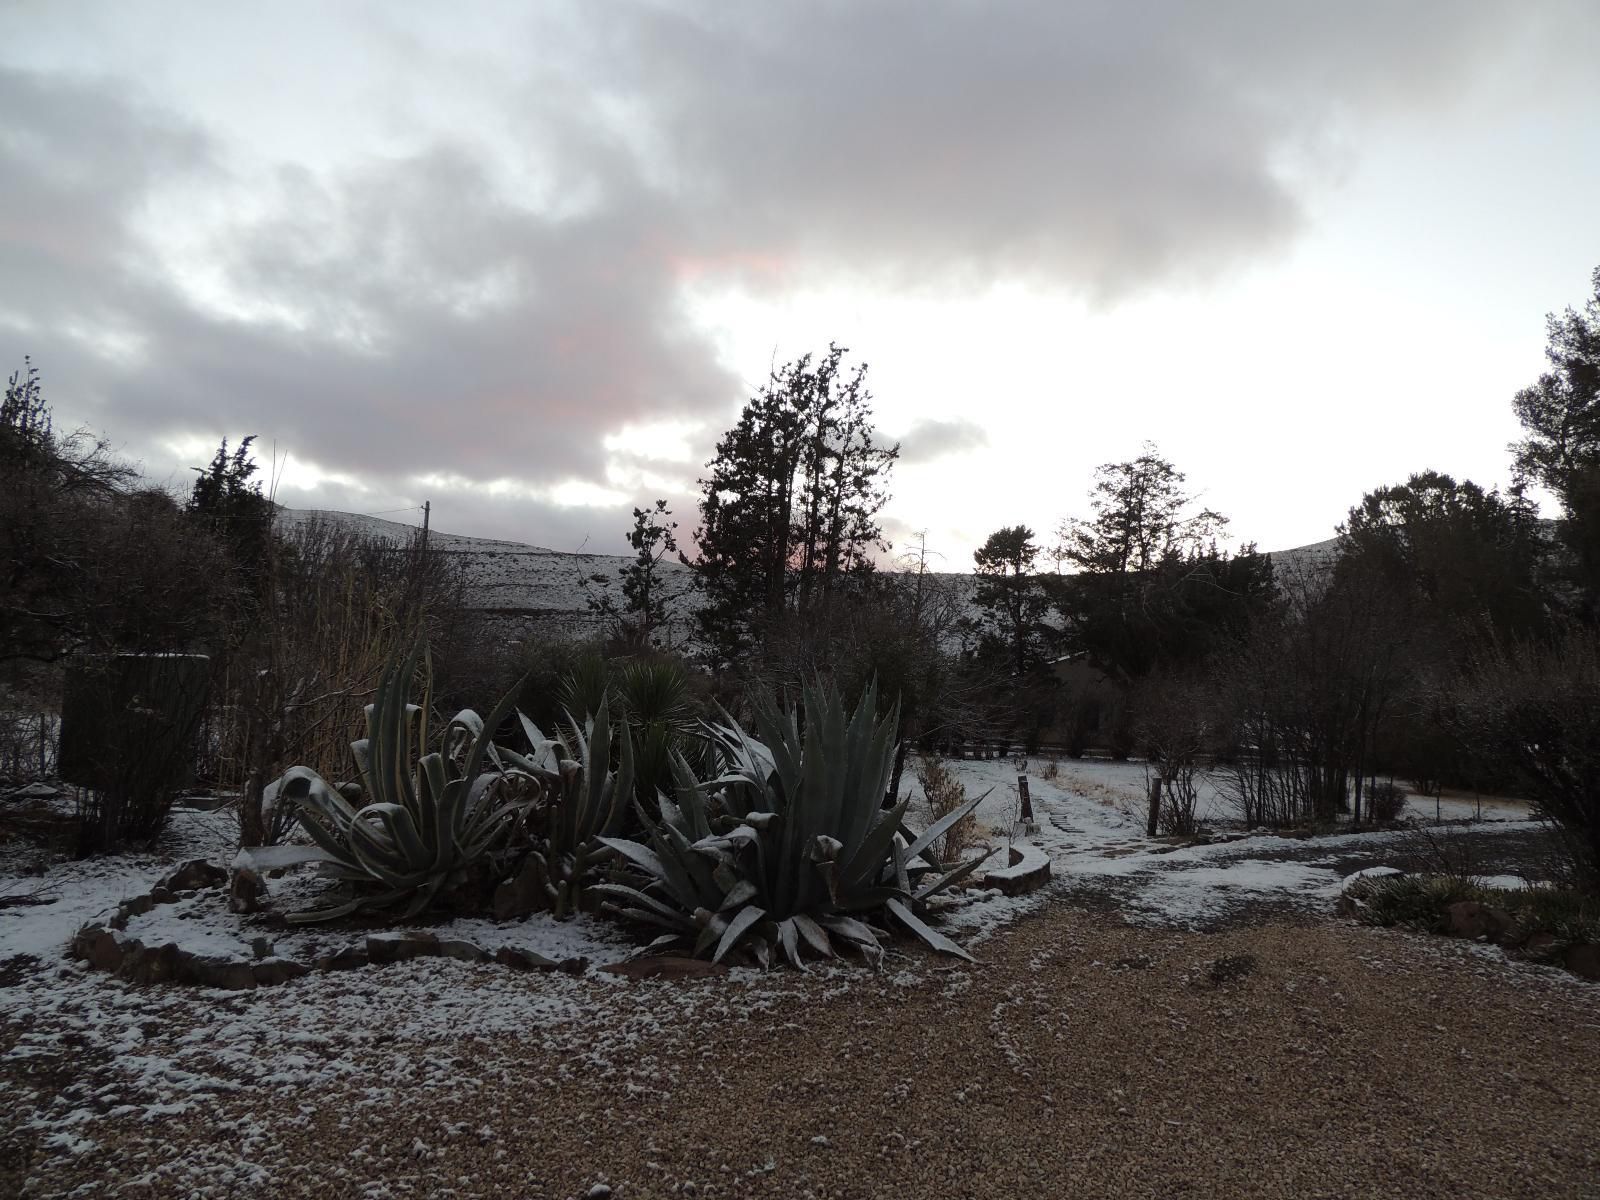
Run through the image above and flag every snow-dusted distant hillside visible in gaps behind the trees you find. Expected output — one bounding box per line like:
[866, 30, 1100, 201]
[278, 509, 1338, 652]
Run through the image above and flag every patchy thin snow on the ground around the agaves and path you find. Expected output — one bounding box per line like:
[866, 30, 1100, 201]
[0, 760, 1568, 1197]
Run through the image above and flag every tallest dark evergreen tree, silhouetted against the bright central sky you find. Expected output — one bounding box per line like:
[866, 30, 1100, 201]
[683, 346, 899, 662]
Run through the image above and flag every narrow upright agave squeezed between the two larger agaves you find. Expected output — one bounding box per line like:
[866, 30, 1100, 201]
[501, 693, 634, 920]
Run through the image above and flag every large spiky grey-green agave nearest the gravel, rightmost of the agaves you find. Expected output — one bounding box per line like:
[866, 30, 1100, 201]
[594, 685, 982, 970]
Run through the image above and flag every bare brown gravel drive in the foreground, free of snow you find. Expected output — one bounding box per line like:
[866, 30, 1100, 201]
[0, 907, 1600, 1200]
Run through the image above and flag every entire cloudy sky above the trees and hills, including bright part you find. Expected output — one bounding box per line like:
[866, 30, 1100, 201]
[0, 0, 1600, 570]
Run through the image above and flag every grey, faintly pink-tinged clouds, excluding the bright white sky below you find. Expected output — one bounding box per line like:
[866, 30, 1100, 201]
[0, 0, 1594, 550]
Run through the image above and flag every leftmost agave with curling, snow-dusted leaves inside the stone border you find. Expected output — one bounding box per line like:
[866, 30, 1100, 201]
[259, 646, 533, 923]
